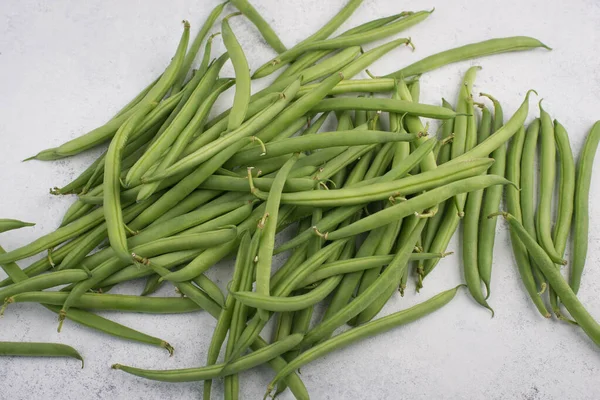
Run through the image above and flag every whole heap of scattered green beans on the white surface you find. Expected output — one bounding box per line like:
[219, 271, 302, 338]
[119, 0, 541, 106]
[0, 0, 600, 400]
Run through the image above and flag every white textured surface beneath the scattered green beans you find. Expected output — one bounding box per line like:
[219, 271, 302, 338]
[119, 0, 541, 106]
[0, 0, 600, 400]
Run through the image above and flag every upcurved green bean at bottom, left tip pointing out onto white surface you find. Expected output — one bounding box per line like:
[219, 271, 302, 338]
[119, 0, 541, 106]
[112, 332, 302, 382]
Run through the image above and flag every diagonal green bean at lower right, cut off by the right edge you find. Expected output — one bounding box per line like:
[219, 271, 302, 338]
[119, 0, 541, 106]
[498, 212, 600, 346]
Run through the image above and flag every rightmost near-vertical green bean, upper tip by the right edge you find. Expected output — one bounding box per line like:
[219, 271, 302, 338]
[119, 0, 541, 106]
[561, 122, 600, 292]
